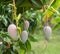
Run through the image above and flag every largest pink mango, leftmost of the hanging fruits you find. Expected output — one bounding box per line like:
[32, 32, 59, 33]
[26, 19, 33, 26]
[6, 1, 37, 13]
[8, 24, 17, 40]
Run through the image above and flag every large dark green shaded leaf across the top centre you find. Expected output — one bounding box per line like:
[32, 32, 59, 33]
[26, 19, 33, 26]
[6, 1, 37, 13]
[16, 0, 43, 9]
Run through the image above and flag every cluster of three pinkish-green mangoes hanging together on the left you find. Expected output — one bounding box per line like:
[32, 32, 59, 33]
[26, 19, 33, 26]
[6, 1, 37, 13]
[8, 20, 29, 44]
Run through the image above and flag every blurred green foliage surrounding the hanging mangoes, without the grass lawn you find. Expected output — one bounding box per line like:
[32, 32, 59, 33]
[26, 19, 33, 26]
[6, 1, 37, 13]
[0, 0, 60, 54]
